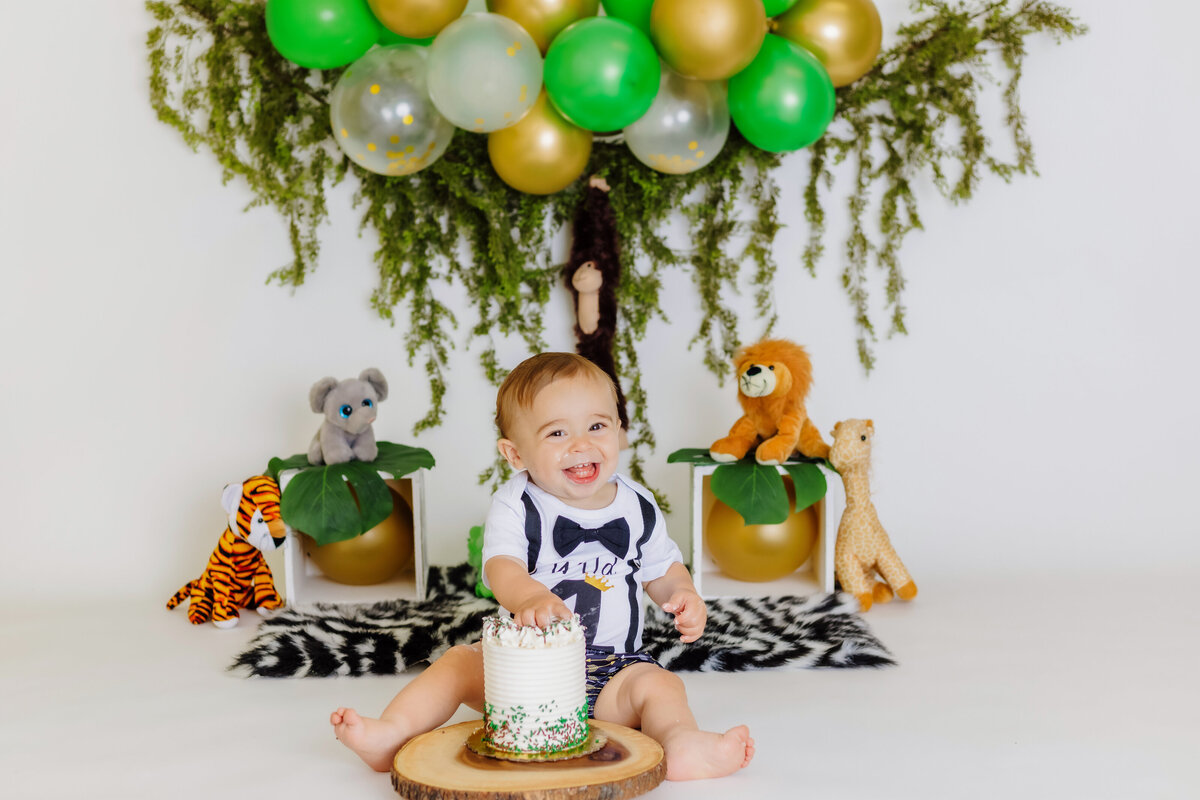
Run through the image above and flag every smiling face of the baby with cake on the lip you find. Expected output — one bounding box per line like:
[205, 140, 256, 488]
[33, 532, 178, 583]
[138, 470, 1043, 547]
[499, 374, 620, 509]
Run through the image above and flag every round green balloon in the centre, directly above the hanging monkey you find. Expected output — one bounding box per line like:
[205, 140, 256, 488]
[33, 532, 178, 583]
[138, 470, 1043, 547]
[542, 17, 661, 132]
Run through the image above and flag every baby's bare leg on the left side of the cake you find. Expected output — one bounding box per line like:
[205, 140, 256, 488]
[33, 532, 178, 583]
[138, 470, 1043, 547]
[329, 642, 484, 772]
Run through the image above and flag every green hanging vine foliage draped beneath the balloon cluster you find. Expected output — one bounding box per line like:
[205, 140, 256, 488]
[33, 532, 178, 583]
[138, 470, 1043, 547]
[146, 0, 1085, 496]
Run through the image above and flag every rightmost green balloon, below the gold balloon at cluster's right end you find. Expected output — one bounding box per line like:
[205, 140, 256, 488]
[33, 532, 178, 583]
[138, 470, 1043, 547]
[730, 34, 836, 152]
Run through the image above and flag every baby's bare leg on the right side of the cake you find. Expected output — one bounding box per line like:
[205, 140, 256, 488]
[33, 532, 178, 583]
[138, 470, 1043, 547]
[595, 663, 754, 781]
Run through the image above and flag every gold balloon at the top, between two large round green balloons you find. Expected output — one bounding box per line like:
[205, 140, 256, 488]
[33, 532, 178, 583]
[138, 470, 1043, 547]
[650, 0, 767, 80]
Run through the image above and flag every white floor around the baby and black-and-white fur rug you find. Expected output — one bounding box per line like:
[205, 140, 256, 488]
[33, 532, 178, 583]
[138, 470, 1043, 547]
[0, 567, 1200, 800]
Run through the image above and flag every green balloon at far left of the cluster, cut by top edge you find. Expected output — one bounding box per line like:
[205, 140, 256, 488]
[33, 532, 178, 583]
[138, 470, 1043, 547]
[266, 0, 379, 70]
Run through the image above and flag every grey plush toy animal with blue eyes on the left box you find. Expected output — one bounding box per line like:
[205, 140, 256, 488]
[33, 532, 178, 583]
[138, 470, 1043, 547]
[308, 367, 388, 464]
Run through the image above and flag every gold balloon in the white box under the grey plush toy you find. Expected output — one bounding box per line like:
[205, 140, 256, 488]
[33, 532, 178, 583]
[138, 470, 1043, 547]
[300, 489, 413, 587]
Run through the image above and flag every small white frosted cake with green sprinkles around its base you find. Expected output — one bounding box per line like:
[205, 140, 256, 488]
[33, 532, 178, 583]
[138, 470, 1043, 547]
[480, 615, 592, 760]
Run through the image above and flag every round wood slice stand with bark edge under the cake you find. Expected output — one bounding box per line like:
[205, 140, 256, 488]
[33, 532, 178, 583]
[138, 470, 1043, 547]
[391, 720, 667, 800]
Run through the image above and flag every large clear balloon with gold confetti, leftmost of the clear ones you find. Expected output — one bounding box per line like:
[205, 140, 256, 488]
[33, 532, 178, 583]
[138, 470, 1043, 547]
[329, 44, 455, 175]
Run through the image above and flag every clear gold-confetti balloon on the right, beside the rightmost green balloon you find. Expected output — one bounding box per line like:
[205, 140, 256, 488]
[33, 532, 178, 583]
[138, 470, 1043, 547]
[625, 66, 730, 175]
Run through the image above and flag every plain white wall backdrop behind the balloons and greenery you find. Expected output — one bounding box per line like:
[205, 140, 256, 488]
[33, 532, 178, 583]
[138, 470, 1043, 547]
[0, 0, 1200, 599]
